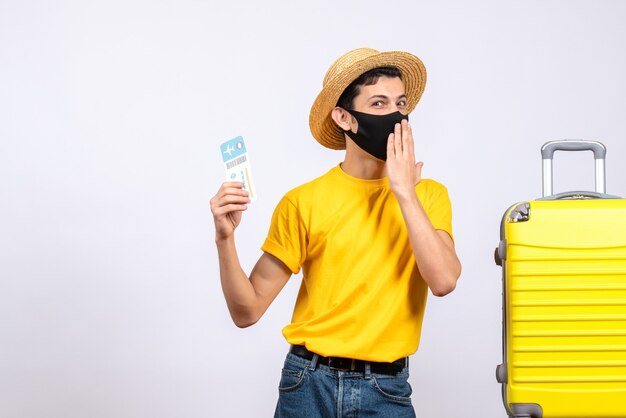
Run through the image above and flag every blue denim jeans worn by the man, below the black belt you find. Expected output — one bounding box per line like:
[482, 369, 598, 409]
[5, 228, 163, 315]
[274, 354, 415, 418]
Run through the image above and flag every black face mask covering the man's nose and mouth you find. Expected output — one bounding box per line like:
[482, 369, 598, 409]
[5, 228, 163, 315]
[344, 110, 409, 161]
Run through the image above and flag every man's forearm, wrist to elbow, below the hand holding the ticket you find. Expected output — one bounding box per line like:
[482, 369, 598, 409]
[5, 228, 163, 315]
[215, 236, 258, 327]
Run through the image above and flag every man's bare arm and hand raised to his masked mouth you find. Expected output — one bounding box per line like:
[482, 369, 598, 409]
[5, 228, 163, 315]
[387, 120, 461, 296]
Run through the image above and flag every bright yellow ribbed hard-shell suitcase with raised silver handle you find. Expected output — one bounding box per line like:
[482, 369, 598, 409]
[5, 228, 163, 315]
[496, 141, 626, 418]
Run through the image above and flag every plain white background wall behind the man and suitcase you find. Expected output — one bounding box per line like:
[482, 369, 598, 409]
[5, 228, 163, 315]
[0, 0, 626, 418]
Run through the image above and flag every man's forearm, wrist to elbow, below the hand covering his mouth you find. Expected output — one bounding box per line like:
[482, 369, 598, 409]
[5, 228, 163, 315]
[398, 190, 461, 296]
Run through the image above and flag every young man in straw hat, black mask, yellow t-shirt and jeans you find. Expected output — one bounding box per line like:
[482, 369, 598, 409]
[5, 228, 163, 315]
[211, 48, 461, 418]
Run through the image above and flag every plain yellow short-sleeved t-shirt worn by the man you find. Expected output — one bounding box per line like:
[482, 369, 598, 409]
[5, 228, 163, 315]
[261, 166, 452, 361]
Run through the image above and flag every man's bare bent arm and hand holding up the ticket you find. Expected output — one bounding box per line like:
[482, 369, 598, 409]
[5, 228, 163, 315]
[211, 182, 291, 328]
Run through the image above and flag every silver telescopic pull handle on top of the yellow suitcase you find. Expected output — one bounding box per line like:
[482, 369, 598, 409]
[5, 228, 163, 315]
[541, 139, 606, 197]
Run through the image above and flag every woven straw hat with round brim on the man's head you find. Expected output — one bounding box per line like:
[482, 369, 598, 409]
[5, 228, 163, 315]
[309, 48, 426, 149]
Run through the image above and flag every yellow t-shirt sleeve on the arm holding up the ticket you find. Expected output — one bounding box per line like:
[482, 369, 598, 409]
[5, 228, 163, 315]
[261, 196, 307, 274]
